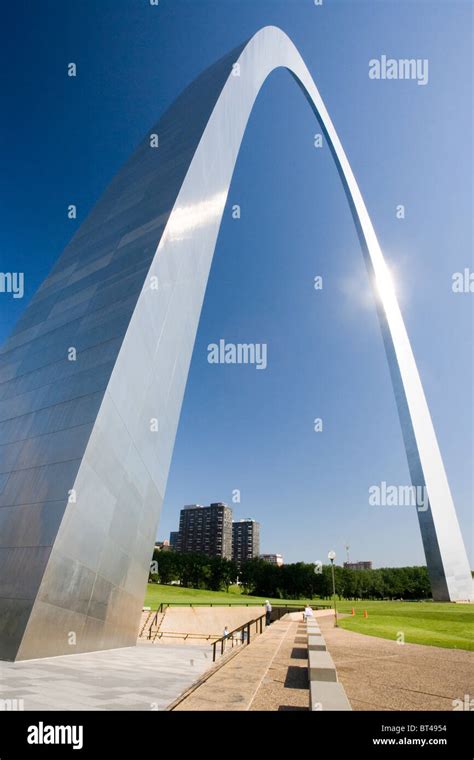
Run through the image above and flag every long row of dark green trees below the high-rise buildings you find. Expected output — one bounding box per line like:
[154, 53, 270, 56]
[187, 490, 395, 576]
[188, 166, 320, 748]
[150, 549, 431, 600]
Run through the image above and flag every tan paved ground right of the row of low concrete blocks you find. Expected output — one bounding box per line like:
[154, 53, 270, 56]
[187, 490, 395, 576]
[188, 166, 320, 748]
[319, 618, 474, 710]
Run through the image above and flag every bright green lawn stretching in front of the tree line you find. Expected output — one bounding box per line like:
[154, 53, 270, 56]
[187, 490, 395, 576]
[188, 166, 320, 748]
[144, 583, 474, 651]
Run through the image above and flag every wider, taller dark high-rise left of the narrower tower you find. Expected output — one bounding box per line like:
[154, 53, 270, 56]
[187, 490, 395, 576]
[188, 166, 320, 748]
[178, 502, 232, 559]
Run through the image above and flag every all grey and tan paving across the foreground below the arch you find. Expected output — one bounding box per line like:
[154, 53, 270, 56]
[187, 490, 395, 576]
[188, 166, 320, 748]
[0, 611, 468, 711]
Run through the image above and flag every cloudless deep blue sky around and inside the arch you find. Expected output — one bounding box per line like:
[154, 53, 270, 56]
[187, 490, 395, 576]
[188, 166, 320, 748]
[0, 0, 474, 566]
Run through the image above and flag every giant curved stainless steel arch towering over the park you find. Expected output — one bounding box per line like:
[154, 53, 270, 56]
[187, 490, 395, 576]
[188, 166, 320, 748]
[0, 27, 472, 660]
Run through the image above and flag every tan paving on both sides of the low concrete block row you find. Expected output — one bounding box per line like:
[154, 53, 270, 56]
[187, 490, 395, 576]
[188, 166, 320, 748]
[175, 611, 474, 711]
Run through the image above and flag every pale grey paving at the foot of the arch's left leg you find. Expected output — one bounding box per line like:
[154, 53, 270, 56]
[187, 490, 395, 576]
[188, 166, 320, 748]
[0, 644, 212, 710]
